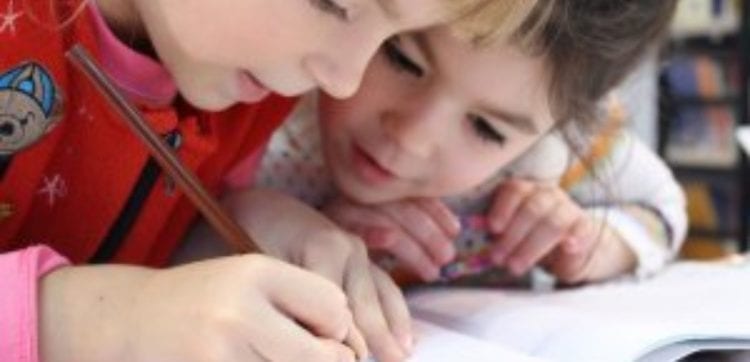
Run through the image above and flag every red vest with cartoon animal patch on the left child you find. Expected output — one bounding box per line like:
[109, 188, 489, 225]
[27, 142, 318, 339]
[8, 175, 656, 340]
[0, 0, 293, 266]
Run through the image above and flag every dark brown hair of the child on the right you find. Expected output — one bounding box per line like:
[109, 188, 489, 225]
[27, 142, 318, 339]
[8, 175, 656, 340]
[513, 0, 677, 129]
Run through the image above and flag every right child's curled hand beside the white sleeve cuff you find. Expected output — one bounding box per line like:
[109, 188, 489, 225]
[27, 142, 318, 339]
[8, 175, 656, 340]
[488, 179, 634, 283]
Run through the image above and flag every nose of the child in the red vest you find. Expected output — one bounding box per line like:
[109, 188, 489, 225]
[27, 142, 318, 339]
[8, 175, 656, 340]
[303, 35, 385, 99]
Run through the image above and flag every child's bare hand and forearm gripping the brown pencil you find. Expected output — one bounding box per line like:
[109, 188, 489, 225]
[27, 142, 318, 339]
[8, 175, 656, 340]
[40, 255, 366, 362]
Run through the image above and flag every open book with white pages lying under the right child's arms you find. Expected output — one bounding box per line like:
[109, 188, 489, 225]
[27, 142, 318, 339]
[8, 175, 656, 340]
[408, 262, 750, 362]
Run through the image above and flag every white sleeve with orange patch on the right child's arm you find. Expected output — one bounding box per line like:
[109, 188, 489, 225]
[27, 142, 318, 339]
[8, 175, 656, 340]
[561, 129, 687, 277]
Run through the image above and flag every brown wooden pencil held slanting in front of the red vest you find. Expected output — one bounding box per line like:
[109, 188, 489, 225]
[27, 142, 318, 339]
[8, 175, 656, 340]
[66, 45, 260, 253]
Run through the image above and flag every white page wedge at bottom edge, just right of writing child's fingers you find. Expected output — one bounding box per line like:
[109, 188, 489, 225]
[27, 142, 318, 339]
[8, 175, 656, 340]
[409, 319, 544, 362]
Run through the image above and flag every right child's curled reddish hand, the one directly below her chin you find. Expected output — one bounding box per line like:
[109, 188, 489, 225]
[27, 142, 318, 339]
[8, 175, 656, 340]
[326, 199, 461, 281]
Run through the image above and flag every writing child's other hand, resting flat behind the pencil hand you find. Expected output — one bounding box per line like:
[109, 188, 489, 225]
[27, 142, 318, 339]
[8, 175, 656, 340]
[228, 190, 413, 362]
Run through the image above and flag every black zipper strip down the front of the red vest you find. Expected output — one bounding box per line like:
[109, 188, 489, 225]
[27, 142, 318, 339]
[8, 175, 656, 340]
[90, 130, 182, 264]
